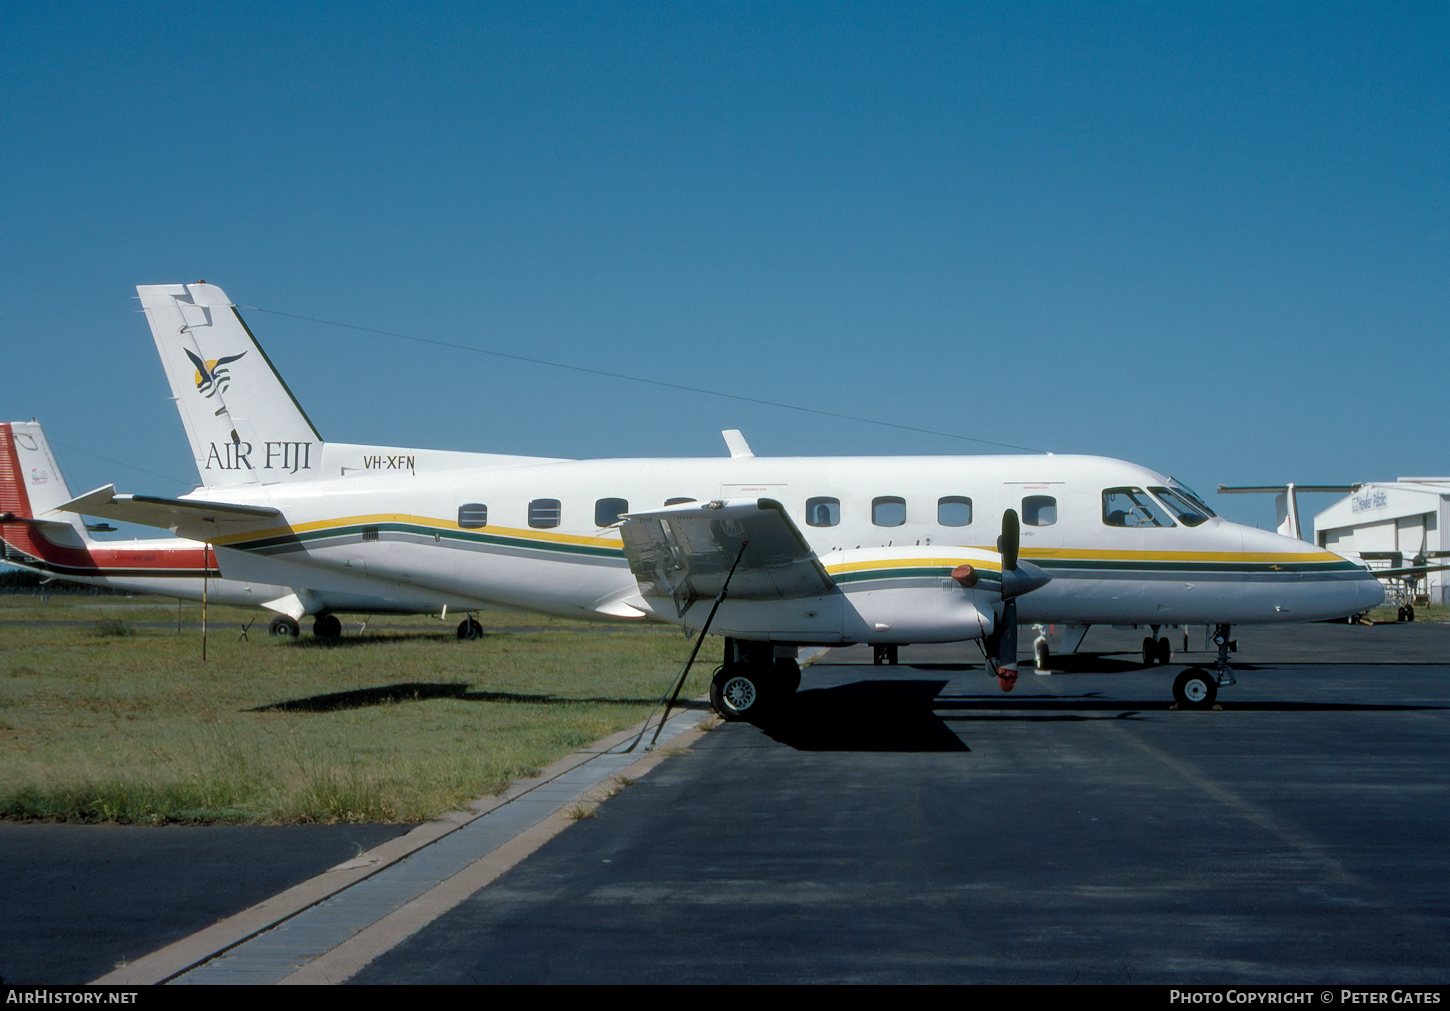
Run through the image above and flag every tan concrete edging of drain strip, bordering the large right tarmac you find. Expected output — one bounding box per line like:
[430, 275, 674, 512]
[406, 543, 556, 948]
[277, 717, 709, 986]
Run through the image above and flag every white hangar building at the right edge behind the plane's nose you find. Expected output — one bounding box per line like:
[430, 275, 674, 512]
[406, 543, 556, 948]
[1314, 477, 1450, 603]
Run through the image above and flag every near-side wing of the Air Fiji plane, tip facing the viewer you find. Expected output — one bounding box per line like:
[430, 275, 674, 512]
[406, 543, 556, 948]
[619, 499, 835, 608]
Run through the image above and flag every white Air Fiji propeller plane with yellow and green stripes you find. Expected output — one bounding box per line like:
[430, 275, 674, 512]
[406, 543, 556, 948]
[65, 283, 1383, 719]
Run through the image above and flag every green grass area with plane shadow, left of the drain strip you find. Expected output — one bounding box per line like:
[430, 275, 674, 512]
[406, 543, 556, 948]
[0, 596, 715, 824]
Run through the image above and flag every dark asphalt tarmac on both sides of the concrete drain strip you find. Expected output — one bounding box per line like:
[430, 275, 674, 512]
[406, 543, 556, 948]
[0, 624, 1450, 983]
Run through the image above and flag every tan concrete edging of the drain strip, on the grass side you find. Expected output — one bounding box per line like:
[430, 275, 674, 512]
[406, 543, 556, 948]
[90, 702, 713, 986]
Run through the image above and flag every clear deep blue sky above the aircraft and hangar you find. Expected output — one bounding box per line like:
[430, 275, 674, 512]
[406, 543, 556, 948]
[0, 0, 1450, 525]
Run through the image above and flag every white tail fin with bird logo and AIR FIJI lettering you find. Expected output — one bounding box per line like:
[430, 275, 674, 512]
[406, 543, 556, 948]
[136, 281, 322, 487]
